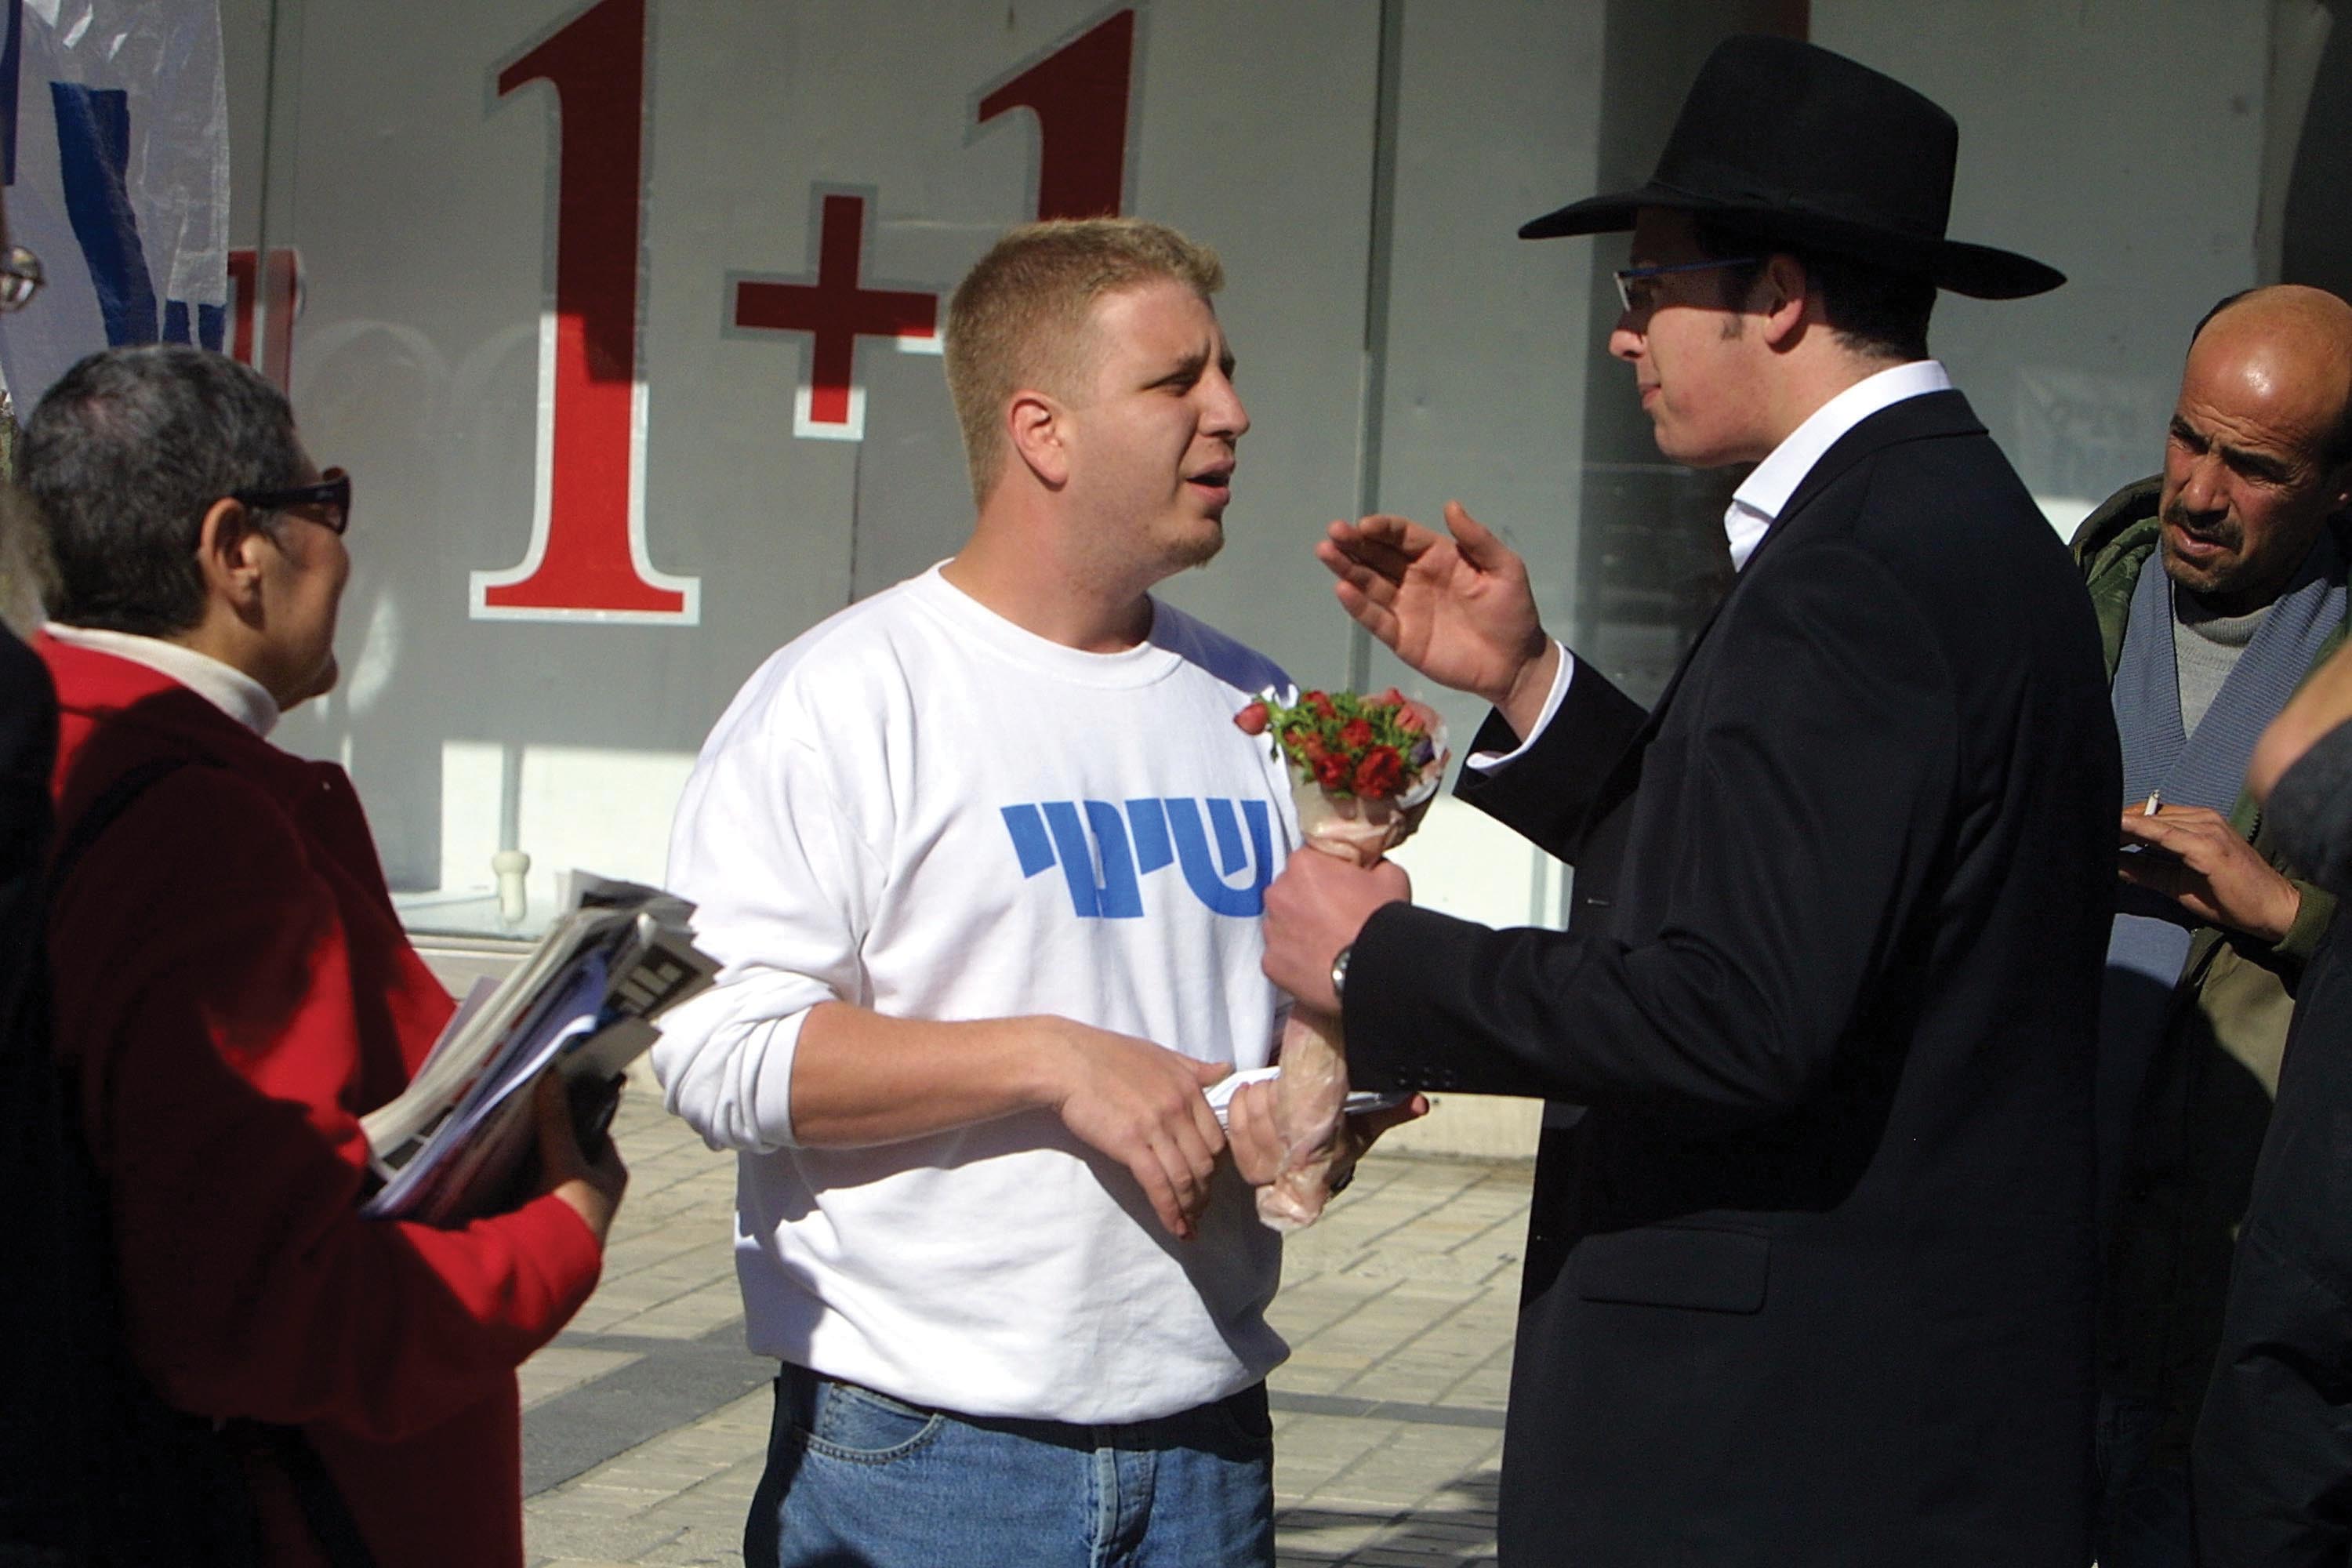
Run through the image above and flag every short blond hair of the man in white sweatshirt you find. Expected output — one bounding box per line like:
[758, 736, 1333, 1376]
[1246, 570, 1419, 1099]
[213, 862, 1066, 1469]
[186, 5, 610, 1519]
[946, 219, 1225, 503]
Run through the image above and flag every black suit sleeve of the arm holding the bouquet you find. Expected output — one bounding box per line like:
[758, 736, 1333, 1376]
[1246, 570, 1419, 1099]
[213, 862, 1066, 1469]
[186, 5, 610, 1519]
[1345, 546, 1959, 1128]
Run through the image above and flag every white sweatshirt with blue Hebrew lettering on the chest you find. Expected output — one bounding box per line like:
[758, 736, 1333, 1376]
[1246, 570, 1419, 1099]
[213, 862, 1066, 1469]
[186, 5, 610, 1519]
[654, 567, 1296, 1422]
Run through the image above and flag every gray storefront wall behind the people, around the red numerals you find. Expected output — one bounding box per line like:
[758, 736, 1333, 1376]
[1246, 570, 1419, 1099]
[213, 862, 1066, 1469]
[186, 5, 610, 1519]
[207, 0, 2352, 924]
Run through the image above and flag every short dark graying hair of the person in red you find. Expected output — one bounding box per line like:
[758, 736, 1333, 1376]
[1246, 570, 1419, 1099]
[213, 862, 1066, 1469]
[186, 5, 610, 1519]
[16, 343, 303, 637]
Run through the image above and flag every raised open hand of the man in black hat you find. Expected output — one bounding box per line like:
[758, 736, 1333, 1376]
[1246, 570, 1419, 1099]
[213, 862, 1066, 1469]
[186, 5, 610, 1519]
[1315, 501, 1552, 734]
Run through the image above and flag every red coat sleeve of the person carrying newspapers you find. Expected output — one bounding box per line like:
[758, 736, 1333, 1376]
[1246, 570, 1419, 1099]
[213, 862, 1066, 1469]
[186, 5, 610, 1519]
[52, 767, 600, 1441]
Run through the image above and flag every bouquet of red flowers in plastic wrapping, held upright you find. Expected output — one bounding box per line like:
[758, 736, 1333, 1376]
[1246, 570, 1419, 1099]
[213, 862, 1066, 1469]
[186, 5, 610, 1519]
[1232, 687, 1446, 1232]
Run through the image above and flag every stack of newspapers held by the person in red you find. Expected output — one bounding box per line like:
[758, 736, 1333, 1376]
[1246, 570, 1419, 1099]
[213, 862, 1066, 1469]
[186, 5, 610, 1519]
[360, 872, 717, 1225]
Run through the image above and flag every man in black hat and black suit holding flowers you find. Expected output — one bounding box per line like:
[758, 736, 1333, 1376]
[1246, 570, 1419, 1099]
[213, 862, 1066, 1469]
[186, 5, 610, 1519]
[1265, 38, 2122, 1568]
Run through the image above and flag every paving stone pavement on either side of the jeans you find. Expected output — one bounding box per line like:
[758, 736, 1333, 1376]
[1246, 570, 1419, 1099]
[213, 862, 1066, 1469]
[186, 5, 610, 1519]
[522, 1093, 1531, 1568]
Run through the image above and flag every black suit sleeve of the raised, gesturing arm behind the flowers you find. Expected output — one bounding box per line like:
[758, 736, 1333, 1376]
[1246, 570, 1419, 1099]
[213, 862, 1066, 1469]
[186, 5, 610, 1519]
[1454, 659, 1649, 865]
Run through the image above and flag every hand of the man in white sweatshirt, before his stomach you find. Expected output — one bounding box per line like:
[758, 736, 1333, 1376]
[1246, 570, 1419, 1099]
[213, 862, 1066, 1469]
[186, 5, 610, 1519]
[1042, 1018, 1230, 1239]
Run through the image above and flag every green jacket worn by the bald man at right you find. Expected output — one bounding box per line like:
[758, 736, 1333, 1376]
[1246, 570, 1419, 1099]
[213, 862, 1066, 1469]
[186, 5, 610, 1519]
[2074, 480, 2352, 1465]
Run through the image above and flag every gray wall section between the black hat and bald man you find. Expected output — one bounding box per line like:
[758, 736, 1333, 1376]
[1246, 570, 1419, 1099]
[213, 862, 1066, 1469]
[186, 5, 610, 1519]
[1813, 0, 2267, 510]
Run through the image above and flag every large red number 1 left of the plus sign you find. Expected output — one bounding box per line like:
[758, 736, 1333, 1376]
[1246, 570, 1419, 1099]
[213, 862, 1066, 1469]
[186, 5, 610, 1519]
[473, 0, 701, 626]
